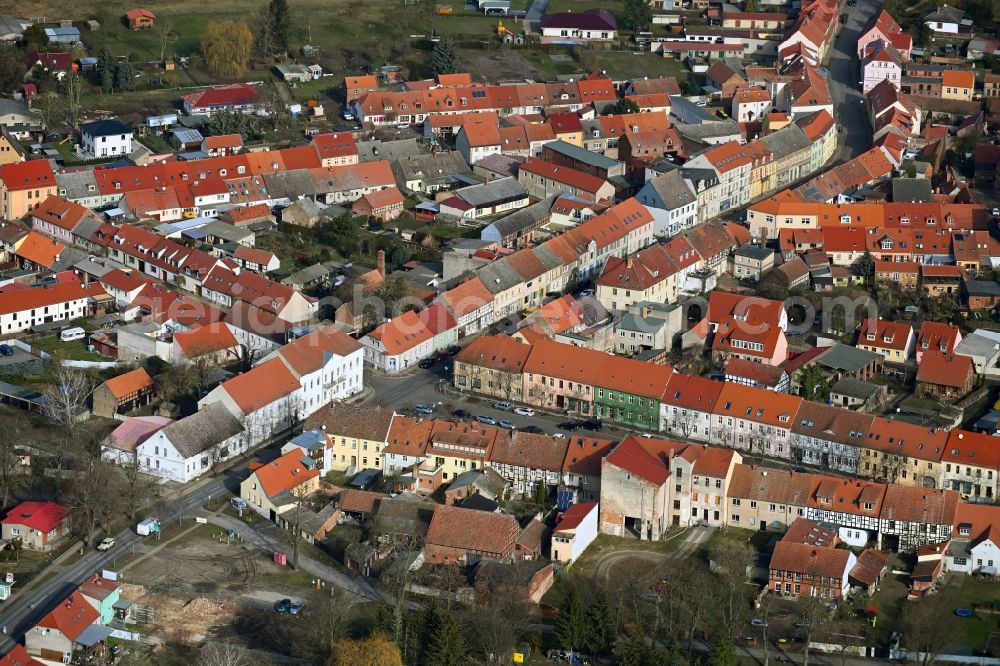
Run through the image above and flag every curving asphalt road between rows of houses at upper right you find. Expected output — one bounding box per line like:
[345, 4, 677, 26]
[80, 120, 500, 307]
[826, 0, 881, 164]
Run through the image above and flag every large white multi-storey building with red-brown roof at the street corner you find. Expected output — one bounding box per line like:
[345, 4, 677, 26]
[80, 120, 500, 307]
[262, 326, 364, 418]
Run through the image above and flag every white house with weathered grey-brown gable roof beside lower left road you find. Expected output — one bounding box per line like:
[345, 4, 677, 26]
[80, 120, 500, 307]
[136, 403, 245, 483]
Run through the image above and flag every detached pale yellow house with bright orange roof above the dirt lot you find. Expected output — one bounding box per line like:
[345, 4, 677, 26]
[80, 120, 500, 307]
[240, 447, 319, 521]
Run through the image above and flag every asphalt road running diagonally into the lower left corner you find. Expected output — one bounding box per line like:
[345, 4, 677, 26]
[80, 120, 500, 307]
[0, 465, 246, 653]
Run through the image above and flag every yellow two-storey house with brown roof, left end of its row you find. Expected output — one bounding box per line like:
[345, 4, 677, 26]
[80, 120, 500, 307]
[305, 402, 396, 472]
